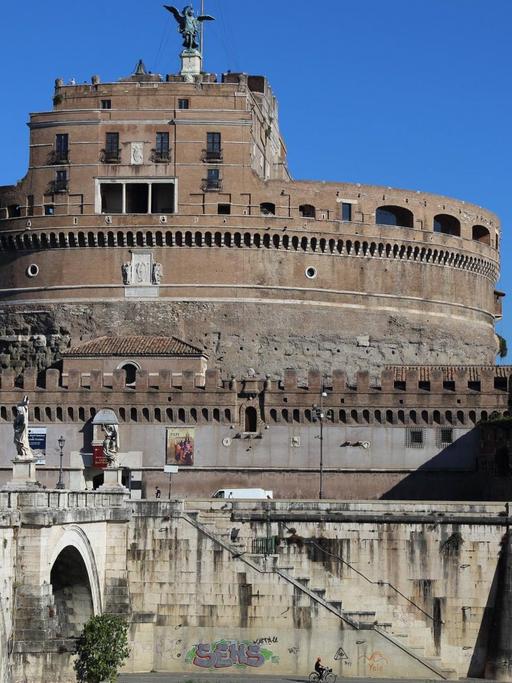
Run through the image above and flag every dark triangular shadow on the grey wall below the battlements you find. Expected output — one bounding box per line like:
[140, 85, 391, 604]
[381, 427, 506, 500]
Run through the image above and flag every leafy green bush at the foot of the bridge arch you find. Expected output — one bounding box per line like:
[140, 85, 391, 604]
[74, 614, 130, 683]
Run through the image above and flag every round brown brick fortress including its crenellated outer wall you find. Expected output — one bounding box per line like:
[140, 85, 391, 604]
[0, 2, 510, 499]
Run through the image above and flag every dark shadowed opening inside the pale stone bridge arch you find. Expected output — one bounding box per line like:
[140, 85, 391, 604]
[50, 546, 94, 638]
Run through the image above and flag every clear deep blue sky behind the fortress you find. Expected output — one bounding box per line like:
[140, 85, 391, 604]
[0, 0, 512, 362]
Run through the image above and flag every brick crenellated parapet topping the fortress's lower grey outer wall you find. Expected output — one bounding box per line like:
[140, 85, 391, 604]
[0, 366, 512, 427]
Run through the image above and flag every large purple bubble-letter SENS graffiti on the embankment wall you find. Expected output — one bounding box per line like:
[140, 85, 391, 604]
[185, 640, 279, 669]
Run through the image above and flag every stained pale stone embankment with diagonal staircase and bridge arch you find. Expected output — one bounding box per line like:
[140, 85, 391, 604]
[0, 490, 511, 683]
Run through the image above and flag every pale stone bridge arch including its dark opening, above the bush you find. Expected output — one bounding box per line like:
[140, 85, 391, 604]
[48, 525, 102, 636]
